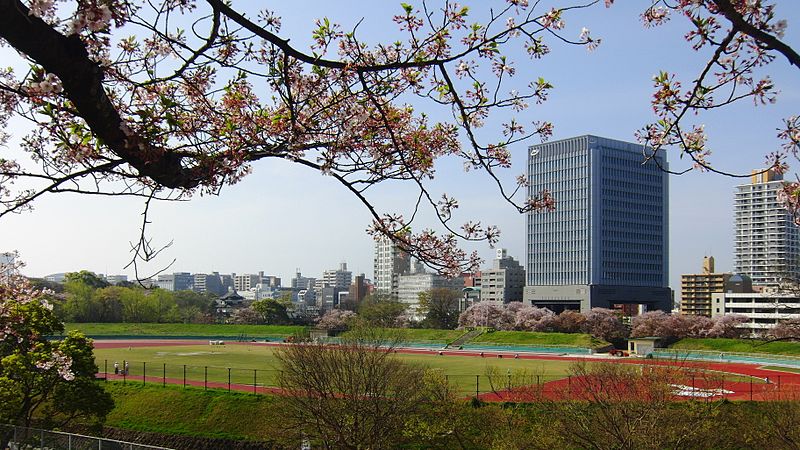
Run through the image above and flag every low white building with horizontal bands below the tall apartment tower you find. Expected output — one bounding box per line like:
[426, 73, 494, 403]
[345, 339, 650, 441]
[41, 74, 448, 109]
[711, 291, 800, 334]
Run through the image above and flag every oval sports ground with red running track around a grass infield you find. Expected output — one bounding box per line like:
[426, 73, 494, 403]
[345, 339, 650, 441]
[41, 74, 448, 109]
[94, 339, 800, 401]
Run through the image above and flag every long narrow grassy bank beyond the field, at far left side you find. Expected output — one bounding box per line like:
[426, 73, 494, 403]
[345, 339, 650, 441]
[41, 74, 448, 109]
[66, 323, 306, 338]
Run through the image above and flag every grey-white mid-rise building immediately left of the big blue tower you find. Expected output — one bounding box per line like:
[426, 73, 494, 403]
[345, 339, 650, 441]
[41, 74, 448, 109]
[480, 248, 525, 303]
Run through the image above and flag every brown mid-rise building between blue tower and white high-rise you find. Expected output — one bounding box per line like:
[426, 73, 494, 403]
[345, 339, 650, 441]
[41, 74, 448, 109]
[681, 256, 752, 317]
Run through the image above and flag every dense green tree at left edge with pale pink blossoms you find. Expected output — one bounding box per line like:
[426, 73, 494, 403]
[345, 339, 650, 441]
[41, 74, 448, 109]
[0, 268, 113, 432]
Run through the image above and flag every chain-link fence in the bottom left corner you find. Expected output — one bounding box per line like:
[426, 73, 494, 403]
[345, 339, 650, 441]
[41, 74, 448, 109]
[0, 424, 170, 450]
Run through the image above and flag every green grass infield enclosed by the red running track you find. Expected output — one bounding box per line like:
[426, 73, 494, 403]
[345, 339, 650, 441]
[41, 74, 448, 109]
[94, 344, 571, 394]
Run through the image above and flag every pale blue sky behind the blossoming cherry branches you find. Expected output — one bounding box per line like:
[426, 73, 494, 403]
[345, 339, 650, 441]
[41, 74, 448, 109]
[0, 1, 800, 294]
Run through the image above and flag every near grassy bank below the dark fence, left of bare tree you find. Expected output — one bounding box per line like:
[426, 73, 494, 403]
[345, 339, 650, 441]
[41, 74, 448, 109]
[101, 382, 280, 441]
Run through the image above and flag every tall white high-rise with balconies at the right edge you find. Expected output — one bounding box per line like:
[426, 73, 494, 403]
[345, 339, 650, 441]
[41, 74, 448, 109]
[733, 167, 800, 287]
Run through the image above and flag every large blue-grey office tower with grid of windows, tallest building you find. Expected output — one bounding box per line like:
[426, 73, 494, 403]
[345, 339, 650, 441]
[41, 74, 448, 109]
[523, 135, 672, 312]
